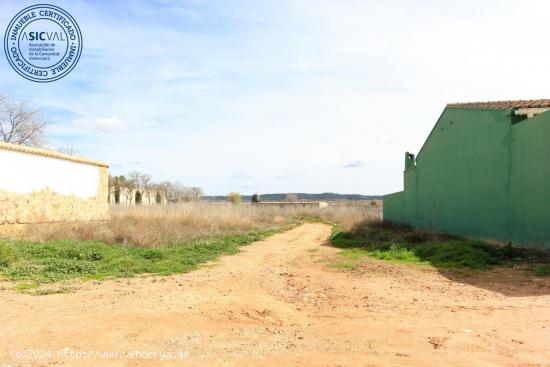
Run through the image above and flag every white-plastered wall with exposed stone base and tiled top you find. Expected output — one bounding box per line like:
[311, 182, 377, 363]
[0, 143, 109, 235]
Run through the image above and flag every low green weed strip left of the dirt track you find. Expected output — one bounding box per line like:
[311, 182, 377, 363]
[0, 229, 275, 284]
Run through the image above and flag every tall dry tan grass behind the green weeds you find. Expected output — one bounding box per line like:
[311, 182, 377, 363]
[27, 202, 384, 246]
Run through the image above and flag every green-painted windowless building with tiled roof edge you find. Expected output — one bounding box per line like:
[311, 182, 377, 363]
[384, 99, 550, 248]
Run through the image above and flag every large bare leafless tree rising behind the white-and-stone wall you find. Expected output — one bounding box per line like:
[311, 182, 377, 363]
[0, 96, 48, 147]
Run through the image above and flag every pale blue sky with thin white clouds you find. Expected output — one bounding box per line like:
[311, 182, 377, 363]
[0, 0, 550, 194]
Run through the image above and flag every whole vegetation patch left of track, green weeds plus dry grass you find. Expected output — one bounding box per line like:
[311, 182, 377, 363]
[0, 202, 380, 284]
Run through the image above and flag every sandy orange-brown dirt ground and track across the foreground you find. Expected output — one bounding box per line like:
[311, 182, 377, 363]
[0, 224, 550, 366]
